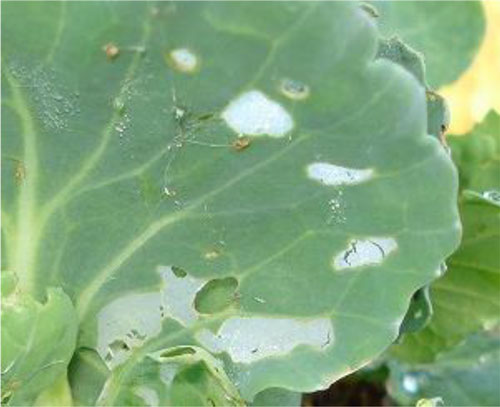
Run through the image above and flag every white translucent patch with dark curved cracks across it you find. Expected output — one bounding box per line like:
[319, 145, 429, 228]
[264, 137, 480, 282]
[333, 237, 398, 270]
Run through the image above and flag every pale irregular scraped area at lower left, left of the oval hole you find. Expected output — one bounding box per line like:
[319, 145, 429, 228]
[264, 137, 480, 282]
[97, 266, 206, 368]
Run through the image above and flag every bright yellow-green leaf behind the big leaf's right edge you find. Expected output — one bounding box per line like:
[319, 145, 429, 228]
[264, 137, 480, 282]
[391, 112, 500, 363]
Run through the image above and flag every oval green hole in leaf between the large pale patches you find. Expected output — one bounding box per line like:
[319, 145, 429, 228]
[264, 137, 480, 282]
[194, 277, 238, 314]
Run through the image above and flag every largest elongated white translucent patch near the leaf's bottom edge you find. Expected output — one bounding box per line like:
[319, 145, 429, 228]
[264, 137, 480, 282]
[197, 317, 334, 363]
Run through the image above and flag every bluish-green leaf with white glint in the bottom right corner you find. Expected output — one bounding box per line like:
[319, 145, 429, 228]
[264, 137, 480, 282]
[388, 333, 500, 406]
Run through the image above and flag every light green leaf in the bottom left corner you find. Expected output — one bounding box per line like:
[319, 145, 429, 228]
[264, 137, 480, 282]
[2, 271, 78, 406]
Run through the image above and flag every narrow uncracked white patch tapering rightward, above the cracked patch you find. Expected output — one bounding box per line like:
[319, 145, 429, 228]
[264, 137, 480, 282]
[307, 163, 374, 186]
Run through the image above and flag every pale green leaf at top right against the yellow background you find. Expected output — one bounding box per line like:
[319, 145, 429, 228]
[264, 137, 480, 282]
[374, 1, 485, 88]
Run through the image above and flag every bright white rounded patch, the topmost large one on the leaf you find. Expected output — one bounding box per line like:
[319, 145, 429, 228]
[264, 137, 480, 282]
[222, 90, 293, 137]
